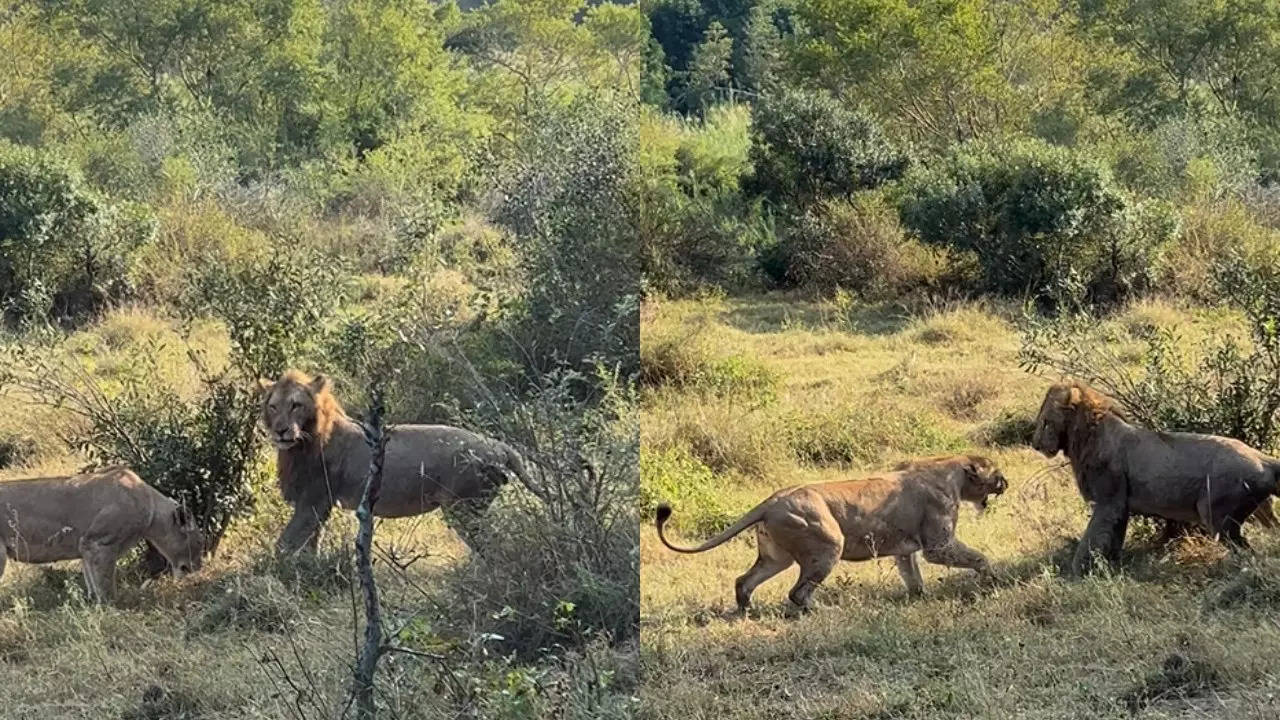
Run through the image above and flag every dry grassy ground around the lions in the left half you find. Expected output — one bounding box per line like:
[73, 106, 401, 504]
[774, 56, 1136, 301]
[0, 307, 636, 720]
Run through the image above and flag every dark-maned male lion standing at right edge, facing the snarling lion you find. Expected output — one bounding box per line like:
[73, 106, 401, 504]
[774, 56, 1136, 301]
[1032, 382, 1280, 573]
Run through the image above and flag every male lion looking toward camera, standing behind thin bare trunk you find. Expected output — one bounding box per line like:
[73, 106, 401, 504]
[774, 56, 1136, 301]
[260, 370, 529, 553]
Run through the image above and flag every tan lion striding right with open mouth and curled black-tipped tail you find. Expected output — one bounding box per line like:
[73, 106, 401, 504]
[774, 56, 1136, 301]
[658, 455, 1006, 611]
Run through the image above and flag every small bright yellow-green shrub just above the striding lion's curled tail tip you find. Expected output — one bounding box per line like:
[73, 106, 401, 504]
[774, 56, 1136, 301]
[640, 447, 732, 533]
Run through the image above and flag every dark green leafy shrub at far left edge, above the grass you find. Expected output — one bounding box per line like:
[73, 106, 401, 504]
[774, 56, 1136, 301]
[0, 142, 154, 320]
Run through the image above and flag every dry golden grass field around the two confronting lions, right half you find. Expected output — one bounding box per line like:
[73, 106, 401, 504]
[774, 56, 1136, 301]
[641, 295, 1280, 720]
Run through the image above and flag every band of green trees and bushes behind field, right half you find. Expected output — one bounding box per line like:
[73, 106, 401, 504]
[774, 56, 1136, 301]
[644, 0, 1280, 304]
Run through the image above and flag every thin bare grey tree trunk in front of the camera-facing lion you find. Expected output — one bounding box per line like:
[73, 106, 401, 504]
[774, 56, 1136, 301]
[353, 388, 387, 720]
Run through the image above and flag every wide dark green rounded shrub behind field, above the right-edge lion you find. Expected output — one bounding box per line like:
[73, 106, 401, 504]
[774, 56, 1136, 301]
[899, 141, 1172, 301]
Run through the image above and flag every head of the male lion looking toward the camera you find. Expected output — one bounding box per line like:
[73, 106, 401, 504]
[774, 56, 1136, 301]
[259, 370, 338, 450]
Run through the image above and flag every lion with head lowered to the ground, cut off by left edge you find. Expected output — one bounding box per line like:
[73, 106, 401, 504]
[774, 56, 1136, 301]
[0, 468, 205, 601]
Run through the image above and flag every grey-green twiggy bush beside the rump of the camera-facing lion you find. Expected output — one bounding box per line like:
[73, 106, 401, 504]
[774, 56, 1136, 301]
[445, 360, 640, 656]
